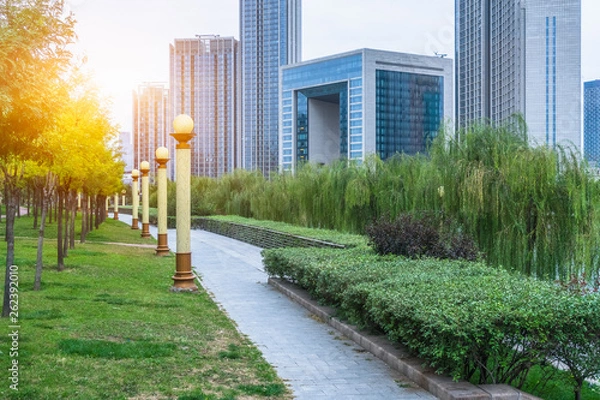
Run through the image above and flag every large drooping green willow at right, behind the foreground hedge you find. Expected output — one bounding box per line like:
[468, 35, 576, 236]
[432, 125, 600, 279]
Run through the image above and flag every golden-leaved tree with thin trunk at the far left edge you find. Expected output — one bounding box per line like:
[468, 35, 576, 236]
[0, 0, 75, 317]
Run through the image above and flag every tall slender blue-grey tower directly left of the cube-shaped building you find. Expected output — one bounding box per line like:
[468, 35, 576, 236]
[240, 0, 302, 175]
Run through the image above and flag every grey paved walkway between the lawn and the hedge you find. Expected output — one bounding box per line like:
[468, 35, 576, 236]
[119, 215, 436, 400]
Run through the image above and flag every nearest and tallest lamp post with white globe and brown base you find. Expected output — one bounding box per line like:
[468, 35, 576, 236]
[171, 114, 198, 292]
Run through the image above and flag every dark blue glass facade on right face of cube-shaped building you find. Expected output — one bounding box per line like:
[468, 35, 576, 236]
[376, 70, 444, 160]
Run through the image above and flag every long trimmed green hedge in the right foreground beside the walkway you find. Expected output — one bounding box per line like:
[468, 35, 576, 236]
[263, 248, 600, 387]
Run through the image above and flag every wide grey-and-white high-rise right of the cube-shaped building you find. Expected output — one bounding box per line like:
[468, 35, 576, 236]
[455, 0, 581, 149]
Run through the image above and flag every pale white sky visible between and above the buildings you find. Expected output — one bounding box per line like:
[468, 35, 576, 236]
[66, 0, 600, 131]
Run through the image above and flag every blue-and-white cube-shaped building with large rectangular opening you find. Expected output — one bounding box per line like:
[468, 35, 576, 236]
[279, 49, 454, 170]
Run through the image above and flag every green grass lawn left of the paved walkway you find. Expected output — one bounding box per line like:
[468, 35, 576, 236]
[0, 217, 291, 400]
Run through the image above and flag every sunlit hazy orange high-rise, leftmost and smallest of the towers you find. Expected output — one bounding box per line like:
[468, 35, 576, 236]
[132, 83, 169, 176]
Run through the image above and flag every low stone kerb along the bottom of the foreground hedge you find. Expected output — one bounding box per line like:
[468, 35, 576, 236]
[268, 277, 542, 400]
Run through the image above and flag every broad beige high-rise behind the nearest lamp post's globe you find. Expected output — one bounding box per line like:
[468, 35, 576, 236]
[169, 35, 241, 178]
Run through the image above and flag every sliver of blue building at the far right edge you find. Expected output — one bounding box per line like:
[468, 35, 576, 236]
[583, 80, 600, 168]
